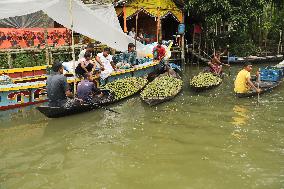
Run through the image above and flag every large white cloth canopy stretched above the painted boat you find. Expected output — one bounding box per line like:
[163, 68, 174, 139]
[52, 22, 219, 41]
[0, 0, 144, 51]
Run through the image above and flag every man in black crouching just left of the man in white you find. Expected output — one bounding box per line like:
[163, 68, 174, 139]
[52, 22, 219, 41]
[75, 51, 96, 77]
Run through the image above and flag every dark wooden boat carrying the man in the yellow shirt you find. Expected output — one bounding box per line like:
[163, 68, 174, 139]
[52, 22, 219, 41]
[236, 81, 281, 98]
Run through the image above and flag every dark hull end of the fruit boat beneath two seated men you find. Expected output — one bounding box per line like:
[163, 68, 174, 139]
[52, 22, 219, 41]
[36, 92, 115, 118]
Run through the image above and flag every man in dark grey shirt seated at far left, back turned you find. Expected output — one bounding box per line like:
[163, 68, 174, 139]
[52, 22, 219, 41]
[46, 61, 73, 107]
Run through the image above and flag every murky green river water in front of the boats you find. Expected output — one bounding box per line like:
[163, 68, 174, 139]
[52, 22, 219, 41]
[0, 64, 284, 189]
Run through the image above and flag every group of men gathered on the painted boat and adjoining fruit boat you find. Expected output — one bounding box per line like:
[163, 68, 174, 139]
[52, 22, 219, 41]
[47, 41, 166, 107]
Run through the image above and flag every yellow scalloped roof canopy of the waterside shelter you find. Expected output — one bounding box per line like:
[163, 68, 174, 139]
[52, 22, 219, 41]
[116, 0, 183, 22]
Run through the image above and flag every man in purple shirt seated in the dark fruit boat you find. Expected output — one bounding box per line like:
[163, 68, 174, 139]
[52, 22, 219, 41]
[77, 72, 103, 103]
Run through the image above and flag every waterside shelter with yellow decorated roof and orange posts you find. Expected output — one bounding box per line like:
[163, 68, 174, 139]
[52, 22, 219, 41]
[116, 0, 183, 42]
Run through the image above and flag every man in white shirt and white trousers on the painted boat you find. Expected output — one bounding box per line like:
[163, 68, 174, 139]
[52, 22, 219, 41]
[96, 48, 115, 79]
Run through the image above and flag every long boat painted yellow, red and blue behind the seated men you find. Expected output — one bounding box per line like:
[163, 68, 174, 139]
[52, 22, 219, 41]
[0, 62, 161, 110]
